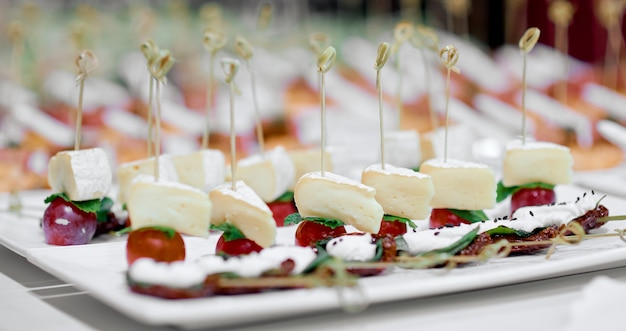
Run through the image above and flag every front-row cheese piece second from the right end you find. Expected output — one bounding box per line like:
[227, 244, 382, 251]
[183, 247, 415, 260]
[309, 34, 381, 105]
[420, 159, 496, 210]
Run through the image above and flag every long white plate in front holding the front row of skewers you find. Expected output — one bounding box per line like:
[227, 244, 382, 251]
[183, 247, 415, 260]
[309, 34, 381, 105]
[27, 186, 626, 328]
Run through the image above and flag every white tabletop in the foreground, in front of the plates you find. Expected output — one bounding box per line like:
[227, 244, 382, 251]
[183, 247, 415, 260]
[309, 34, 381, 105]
[0, 241, 626, 330]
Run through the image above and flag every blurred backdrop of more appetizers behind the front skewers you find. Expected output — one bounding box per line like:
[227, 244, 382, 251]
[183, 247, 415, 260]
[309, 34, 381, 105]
[0, 0, 626, 191]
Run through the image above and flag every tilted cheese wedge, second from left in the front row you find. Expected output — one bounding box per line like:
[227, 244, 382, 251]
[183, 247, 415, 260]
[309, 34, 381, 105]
[209, 181, 276, 247]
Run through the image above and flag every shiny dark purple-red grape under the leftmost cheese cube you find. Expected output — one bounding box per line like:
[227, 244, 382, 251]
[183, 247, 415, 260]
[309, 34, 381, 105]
[41, 197, 98, 246]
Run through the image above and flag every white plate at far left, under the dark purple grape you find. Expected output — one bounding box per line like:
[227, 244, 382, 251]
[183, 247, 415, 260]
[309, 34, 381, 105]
[0, 190, 126, 256]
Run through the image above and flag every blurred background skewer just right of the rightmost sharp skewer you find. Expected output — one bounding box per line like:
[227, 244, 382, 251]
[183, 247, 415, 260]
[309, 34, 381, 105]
[548, 0, 575, 103]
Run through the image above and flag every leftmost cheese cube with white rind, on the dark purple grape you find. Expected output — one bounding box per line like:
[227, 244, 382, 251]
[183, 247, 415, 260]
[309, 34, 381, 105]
[48, 148, 113, 201]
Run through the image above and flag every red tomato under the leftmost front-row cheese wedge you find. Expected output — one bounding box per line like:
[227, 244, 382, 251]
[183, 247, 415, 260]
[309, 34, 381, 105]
[126, 227, 185, 265]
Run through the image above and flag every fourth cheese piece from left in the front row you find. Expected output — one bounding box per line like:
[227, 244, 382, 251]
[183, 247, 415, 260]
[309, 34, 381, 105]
[361, 164, 435, 220]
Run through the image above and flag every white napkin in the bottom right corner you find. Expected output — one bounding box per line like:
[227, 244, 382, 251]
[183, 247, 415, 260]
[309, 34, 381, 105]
[566, 276, 626, 331]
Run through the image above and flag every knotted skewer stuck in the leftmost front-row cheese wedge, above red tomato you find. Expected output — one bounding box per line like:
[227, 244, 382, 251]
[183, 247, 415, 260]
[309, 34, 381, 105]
[150, 50, 174, 181]
